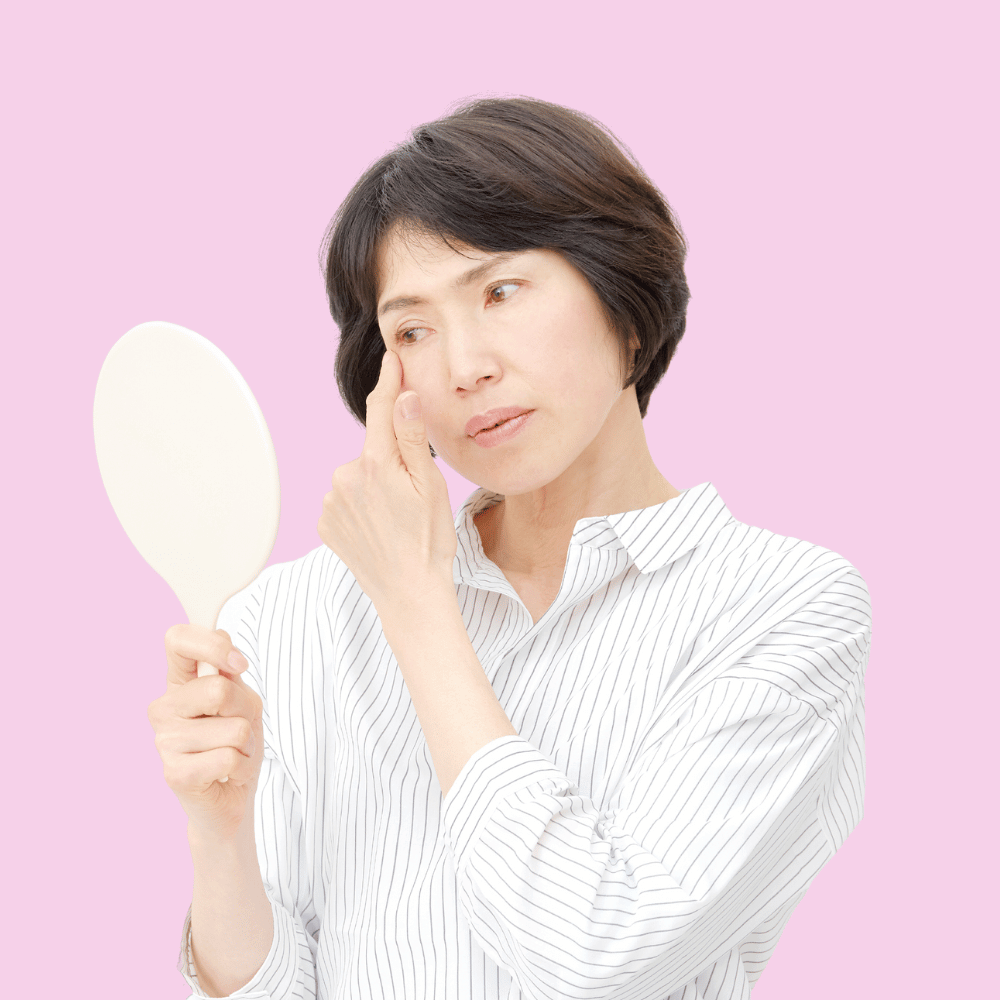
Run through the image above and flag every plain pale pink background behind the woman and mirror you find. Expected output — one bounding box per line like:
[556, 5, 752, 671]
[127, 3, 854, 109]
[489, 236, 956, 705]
[0, 0, 1000, 1000]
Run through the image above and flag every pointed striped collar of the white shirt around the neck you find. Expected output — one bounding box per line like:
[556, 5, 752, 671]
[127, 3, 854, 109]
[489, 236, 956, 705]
[454, 483, 734, 583]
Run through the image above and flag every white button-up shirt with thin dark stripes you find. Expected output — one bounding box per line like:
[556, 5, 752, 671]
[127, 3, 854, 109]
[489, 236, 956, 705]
[178, 483, 871, 1000]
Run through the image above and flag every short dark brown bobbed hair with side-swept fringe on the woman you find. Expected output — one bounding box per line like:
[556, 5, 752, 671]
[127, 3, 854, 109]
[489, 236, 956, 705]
[320, 97, 690, 455]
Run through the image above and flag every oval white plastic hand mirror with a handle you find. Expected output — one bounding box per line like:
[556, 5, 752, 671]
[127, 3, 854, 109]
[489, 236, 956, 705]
[94, 322, 280, 677]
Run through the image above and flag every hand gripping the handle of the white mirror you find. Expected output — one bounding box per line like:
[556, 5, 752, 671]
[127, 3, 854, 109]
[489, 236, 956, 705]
[147, 625, 264, 841]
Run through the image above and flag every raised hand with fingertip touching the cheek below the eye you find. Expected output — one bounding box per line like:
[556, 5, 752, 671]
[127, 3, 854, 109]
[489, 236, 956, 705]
[317, 351, 458, 615]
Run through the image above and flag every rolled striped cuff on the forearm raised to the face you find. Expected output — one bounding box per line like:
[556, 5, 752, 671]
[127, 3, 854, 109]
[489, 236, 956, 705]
[441, 736, 579, 872]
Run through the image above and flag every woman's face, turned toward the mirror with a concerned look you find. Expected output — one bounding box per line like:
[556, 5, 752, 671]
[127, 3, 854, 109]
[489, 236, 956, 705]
[378, 230, 637, 495]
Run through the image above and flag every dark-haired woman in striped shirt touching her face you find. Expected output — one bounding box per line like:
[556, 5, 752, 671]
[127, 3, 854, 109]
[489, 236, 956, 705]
[150, 99, 870, 1000]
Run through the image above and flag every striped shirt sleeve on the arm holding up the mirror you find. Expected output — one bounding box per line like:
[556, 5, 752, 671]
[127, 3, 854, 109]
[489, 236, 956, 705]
[177, 570, 319, 1000]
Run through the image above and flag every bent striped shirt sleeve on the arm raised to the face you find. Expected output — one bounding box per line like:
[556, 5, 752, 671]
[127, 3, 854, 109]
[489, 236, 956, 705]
[442, 564, 870, 1000]
